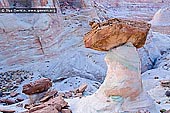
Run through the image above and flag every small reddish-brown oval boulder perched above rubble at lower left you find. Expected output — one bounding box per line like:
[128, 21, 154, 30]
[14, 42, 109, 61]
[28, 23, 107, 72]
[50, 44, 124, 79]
[22, 78, 52, 95]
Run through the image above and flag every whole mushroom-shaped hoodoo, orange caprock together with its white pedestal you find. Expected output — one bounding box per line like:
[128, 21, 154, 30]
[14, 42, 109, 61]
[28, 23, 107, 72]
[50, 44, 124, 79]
[69, 19, 156, 113]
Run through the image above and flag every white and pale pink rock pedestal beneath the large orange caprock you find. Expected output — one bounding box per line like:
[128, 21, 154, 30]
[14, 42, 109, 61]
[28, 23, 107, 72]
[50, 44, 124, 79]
[70, 43, 157, 113]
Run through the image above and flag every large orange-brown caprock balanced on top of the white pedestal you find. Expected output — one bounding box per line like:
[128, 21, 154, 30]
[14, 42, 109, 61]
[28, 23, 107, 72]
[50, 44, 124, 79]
[84, 18, 150, 51]
